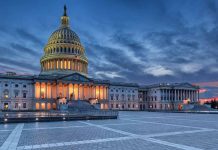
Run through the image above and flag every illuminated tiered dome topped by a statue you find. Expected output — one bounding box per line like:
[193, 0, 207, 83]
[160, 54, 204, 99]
[40, 6, 88, 75]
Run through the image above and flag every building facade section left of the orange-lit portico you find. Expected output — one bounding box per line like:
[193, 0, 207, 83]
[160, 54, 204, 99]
[0, 72, 34, 110]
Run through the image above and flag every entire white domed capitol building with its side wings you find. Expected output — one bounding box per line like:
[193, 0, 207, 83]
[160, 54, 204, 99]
[0, 7, 199, 110]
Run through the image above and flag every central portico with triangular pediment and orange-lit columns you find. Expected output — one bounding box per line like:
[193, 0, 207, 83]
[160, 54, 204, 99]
[34, 73, 108, 109]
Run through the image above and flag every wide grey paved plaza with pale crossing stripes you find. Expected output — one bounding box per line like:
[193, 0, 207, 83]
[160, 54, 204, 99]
[0, 112, 218, 150]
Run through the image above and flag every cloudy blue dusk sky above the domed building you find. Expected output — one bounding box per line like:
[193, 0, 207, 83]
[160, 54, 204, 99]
[0, 0, 218, 97]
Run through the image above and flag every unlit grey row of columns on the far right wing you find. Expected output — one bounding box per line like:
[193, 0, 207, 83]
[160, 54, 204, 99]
[161, 89, 199, 101]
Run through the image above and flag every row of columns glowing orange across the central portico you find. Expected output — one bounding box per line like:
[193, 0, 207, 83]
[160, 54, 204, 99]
[35, 82, 108, 100]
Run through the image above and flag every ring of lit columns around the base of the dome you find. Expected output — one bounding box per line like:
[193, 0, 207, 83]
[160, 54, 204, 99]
[42, 59, 87, 73]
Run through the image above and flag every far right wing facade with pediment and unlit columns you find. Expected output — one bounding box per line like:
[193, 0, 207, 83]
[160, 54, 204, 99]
[139, 83, 199, 110]
